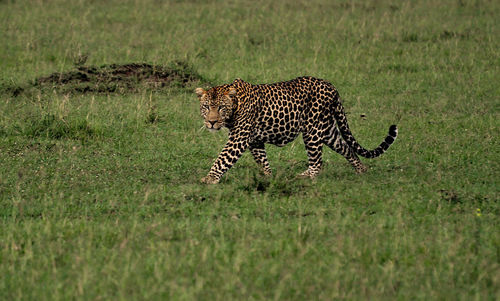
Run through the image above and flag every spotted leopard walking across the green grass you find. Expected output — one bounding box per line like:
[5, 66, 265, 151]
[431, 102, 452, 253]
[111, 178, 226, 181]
[195, 76, 398, 184]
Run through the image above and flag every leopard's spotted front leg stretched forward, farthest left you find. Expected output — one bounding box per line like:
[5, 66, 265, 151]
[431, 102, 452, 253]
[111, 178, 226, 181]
[201, 131, 248, 184]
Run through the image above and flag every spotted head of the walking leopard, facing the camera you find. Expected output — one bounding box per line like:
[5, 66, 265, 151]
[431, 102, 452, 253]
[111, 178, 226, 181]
[195, 85, 236, 130]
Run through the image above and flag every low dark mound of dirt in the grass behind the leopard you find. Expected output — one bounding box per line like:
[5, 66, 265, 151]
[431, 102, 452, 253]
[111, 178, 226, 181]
[3, 62, 208, 96]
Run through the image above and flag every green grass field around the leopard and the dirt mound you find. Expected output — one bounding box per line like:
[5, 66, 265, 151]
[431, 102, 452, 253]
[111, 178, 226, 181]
[0, 0, 500, 300]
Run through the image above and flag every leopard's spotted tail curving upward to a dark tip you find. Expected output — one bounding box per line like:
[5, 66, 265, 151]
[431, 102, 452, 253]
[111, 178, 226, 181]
[334, 100, 398, 158]
